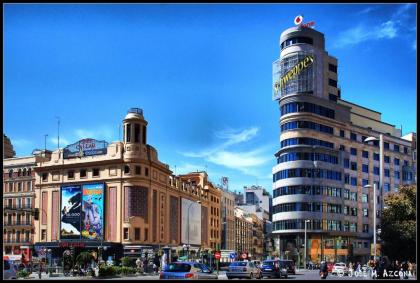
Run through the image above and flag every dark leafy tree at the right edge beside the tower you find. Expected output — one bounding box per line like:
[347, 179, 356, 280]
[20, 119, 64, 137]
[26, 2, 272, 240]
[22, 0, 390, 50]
[380, 185, 417, 261]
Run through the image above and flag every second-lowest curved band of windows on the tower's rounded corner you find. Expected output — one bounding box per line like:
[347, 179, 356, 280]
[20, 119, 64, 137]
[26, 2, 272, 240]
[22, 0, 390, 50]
[273, 202, 341, 213]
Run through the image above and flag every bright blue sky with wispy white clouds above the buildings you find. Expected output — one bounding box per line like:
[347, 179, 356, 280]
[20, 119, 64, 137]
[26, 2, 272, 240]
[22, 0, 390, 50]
[3, 4, 417, 195]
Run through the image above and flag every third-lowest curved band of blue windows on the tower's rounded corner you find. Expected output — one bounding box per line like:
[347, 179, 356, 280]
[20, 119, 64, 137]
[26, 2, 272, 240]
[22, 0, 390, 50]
[273, 186, 341, 198]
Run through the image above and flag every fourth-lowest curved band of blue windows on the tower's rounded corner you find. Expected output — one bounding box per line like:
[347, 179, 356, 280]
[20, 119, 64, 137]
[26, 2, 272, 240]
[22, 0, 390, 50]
[273, 168, 341, 182]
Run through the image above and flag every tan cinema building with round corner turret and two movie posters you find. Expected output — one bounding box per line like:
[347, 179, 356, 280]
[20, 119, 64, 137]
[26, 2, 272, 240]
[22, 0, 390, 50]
[34, 108, 221, 262]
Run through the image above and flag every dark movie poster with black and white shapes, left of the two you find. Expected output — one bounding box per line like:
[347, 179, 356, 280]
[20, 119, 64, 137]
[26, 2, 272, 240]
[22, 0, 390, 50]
[60, 185, 82, 239]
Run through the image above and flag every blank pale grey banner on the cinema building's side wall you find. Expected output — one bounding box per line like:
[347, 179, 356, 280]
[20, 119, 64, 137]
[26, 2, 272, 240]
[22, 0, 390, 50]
[181, 198, 201, 245]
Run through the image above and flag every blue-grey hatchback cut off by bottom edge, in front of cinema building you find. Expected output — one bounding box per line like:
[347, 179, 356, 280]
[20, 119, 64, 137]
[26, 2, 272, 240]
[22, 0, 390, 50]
[159, 261, 218, 279]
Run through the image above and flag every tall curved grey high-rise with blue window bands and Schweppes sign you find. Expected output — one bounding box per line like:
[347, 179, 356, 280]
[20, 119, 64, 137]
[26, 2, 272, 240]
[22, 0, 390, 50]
[272, 25, 414, 265]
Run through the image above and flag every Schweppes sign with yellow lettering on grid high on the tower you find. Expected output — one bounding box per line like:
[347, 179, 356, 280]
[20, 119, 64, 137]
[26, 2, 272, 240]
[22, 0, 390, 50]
[273, 51, 315, 100]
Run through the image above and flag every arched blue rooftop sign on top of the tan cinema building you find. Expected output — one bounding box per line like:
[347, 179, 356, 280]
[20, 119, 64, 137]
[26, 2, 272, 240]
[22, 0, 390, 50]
[63, 139, 108, 158]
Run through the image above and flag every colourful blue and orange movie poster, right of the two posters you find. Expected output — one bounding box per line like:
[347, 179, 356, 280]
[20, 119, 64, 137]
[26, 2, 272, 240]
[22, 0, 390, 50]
[82, 183, 105, 240]
